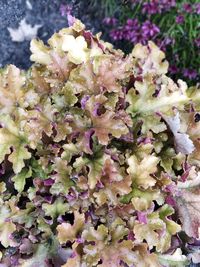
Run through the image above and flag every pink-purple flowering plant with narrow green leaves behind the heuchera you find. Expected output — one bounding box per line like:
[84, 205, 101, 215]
[99, 0, 200, 85]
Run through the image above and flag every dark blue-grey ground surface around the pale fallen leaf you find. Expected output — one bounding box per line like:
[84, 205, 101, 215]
[0, 0, 101, 69]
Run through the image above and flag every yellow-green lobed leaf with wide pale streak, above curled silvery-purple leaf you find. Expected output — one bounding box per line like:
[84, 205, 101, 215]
[127, 77, 189, 116]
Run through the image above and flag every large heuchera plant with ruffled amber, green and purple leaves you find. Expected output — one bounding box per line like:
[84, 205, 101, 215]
[0, 17, 200, 267]
